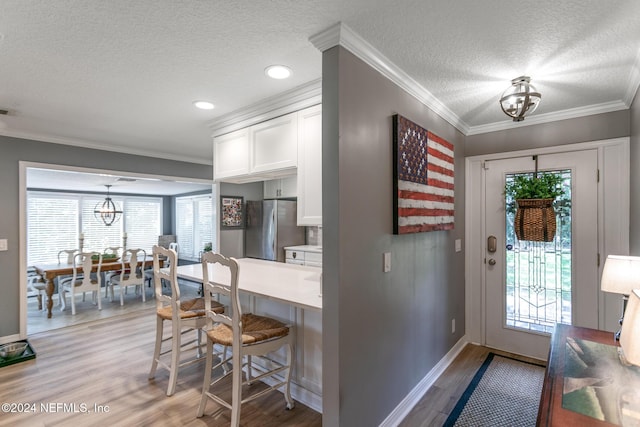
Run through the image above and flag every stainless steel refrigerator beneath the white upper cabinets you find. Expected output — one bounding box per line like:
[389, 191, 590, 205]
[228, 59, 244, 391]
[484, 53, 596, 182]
[244, 200, 305, 262]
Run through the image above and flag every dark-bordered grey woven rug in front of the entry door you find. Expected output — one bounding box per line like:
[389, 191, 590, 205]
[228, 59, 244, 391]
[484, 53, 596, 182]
[444, 353, 544, 427]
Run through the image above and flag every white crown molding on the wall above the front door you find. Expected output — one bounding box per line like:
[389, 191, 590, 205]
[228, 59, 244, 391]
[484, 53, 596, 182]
[466, 101, 629, 136]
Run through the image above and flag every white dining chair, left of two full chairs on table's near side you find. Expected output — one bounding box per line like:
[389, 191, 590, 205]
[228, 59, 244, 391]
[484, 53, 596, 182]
[59, 252, 102, 315]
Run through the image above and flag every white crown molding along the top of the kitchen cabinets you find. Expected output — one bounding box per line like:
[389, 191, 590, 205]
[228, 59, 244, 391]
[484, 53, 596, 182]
[207, 79, 322, 137]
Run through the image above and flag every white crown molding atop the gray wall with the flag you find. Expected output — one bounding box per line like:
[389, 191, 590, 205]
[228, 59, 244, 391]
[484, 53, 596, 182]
[309, 22, 469, 134]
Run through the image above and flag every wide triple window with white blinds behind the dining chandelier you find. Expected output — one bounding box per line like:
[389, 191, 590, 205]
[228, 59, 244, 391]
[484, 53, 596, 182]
[27, 191, 162, 264]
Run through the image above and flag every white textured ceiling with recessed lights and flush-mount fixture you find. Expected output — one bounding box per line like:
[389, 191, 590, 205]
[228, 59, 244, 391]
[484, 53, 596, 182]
[0, 0, 640, 163]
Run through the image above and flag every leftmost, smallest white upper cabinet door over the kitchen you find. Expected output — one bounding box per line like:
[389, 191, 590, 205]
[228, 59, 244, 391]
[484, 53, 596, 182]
[213, 128, 249, 180]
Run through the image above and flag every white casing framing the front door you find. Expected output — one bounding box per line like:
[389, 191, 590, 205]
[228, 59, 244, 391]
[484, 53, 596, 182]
[464, 137, 630, 359]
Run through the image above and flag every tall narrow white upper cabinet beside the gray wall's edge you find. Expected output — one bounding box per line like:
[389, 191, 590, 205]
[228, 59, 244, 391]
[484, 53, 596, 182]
[297, 105, 322, 225]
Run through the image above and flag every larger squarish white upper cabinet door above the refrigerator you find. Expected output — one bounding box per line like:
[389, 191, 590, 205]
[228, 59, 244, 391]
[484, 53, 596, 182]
[249, 113, 298, 173]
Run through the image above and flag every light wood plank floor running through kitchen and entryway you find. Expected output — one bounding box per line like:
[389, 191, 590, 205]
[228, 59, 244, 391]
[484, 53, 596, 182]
[16, 296, 541, 427]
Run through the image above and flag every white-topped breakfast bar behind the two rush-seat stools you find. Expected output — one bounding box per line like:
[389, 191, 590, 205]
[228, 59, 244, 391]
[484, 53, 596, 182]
[176, 258, 322, 412]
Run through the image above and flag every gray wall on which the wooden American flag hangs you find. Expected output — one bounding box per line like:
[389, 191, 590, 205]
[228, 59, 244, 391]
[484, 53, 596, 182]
[322, 47, 465, 426]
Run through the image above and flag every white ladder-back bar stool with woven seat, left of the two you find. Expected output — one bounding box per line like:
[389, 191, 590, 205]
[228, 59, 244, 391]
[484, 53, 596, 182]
[149, 245, 224, 396]
